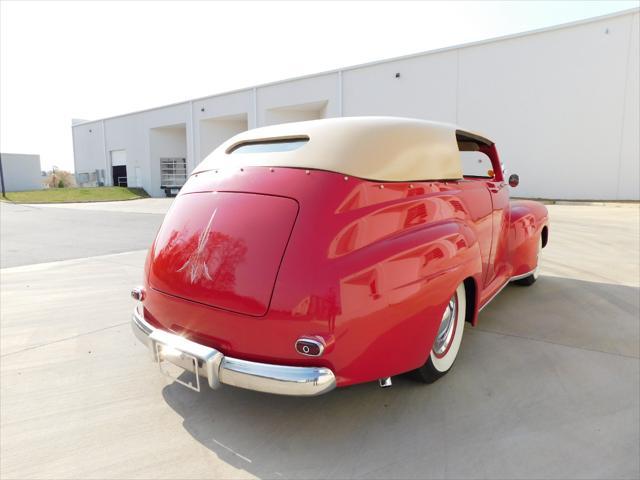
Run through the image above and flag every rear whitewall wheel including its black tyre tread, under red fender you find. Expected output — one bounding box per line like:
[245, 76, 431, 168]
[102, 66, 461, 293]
[416, 283, 467, 383]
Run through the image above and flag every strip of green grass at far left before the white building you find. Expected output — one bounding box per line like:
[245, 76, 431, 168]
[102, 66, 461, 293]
[0, 187, 149, 203]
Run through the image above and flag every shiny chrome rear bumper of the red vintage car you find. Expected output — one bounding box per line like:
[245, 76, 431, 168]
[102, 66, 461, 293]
[131, 308, 336, 396]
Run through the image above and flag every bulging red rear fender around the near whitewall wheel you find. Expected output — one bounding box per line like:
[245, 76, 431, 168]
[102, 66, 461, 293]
[316, 220, 482, 384]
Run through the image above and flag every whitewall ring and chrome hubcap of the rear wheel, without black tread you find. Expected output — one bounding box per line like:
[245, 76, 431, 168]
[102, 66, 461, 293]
[430, 284, 466, 372]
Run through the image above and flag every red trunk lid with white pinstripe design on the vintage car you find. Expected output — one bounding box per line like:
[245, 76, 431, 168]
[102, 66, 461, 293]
[149, 192, 298, 316]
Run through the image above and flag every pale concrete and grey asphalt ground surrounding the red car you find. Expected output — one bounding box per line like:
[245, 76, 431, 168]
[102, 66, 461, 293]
[0, 201, 640, 478]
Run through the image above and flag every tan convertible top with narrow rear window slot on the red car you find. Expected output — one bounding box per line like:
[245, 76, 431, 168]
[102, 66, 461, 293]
[194, 117, 492, 181]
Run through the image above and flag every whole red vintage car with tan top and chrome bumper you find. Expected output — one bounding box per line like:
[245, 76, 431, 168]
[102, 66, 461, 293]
[132, 117, 549, 395]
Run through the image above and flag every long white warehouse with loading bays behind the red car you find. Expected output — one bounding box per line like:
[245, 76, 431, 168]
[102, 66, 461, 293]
[72, 9, 640, 200]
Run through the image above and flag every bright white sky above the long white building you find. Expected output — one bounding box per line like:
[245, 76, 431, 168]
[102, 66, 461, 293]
[0, 0, 640, 170]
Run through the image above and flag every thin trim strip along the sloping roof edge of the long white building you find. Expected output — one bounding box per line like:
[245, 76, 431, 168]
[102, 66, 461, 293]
[71, 7, 640, 129]
